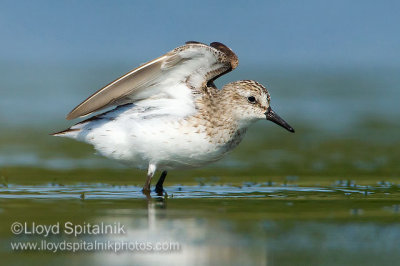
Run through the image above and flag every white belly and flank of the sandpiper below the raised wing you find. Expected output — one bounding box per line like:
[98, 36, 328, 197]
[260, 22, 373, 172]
[64, 102, 238, 170]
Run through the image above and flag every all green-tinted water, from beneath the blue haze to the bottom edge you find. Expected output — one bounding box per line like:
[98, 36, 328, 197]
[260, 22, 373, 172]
[0, 124, 400, 265]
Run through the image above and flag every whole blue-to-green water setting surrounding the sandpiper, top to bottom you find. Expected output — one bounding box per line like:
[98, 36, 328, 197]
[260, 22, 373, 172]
[0, 0, 400, 265]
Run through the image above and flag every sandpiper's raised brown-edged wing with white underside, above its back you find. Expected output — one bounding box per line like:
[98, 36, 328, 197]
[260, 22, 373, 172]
[67, 42, 238, 119]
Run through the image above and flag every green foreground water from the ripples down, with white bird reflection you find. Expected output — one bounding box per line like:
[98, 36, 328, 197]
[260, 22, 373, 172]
[0, 171, 400, 265]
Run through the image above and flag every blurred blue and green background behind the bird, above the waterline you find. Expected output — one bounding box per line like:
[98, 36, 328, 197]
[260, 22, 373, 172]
[0, 0, 400, 174]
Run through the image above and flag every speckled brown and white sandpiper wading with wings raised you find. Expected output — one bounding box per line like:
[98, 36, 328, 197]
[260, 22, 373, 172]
[53, 41, 294, 194]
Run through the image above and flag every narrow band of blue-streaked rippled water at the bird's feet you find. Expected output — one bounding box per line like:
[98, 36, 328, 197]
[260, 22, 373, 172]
[0, 183, 400, 199]
